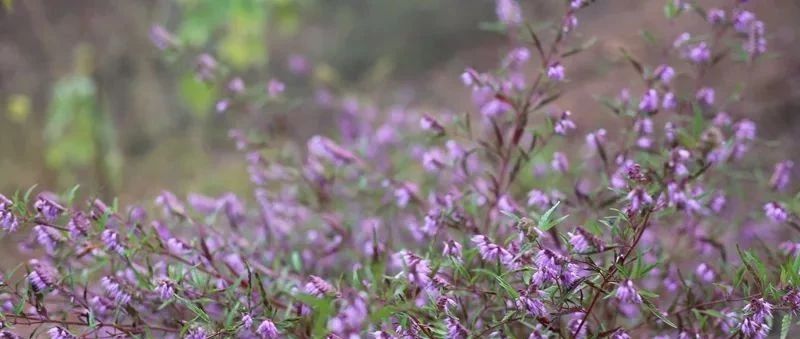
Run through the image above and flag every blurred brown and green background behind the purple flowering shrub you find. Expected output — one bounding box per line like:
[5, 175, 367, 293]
[0, 0, 800, 204]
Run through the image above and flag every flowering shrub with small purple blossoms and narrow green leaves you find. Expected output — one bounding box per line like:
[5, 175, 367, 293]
[0, 0, 800, 338]
